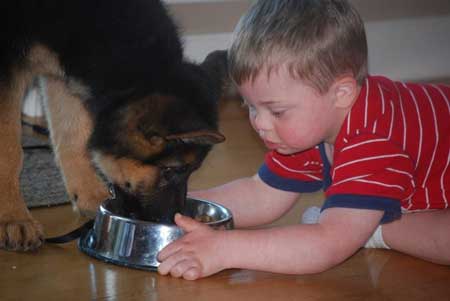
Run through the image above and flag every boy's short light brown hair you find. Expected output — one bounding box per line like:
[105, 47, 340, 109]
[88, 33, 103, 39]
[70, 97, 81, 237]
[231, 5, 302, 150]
[228, 0, 368, 93]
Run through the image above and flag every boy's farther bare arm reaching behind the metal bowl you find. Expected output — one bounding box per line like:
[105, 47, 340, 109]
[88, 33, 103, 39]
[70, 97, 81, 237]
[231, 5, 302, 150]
[189, 175, 299, 228]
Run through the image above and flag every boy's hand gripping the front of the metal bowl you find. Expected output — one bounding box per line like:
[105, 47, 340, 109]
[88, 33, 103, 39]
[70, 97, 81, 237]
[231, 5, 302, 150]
[158, 213, 226, 280]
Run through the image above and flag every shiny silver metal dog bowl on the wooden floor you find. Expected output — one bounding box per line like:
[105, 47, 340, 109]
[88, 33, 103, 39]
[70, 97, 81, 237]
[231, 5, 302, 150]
[78, 198, 233, 270]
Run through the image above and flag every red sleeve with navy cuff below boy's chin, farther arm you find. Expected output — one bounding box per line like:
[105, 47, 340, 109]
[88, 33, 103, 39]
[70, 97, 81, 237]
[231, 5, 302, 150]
[258, 147, 323, 192]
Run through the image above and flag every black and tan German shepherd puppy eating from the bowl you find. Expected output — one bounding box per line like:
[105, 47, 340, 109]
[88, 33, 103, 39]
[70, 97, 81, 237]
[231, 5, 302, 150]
[0, 0, 226, 251]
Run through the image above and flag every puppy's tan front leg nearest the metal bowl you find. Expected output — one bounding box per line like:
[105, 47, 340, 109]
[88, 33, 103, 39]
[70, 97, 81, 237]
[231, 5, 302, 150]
[41, 78, 109, 216]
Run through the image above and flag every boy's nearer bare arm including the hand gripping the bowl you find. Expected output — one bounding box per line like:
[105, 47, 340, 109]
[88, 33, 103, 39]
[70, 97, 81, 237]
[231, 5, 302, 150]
[158, 208, 383, 279]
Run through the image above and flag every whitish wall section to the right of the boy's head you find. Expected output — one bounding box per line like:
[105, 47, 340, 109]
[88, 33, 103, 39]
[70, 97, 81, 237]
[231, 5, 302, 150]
[366, 16, 450, 80]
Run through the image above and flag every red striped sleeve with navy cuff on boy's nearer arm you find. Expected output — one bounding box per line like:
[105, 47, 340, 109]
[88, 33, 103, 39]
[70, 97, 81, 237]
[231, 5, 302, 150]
[323, 134, 415, 223]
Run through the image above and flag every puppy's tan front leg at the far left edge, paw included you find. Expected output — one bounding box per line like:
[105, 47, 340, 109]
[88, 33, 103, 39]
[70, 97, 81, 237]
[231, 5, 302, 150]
[0, 72, 44, 251]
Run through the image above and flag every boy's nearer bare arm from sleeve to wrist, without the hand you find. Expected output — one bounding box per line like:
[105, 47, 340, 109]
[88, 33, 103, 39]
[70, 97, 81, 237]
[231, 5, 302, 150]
[222, 208, 383, 274]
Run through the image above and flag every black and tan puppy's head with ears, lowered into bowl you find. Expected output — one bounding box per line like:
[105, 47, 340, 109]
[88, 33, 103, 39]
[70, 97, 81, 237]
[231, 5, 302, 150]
[89, 52, 226, 218]
